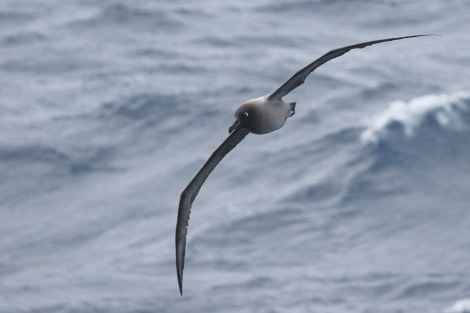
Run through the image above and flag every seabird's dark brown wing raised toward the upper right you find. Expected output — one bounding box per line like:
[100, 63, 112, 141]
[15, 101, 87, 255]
[269, 35, 431, 100]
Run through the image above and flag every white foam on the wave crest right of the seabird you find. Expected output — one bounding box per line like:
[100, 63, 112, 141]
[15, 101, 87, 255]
[361, 92, 470, 144]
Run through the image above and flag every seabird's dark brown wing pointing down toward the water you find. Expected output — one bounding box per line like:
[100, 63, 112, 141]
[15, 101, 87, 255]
[175, 127, 249, 295]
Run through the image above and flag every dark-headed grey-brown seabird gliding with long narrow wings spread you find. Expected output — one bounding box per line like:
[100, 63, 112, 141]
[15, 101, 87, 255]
[175, 35, 429, 295]
